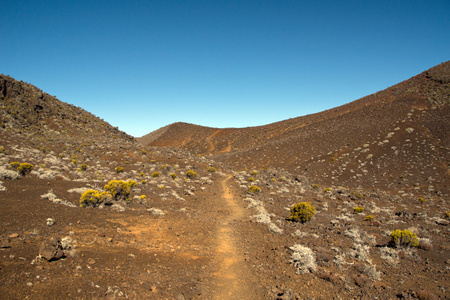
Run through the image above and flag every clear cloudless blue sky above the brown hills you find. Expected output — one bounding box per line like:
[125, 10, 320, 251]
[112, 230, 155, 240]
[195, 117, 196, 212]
[0, 0, 450, 137]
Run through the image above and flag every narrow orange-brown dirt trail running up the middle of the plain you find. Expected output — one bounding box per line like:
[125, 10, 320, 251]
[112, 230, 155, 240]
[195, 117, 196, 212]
[212, 175, 256, 299]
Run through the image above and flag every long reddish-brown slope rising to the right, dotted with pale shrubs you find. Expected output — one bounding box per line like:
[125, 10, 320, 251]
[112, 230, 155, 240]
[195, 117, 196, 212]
[140, 62, 450, 193]
